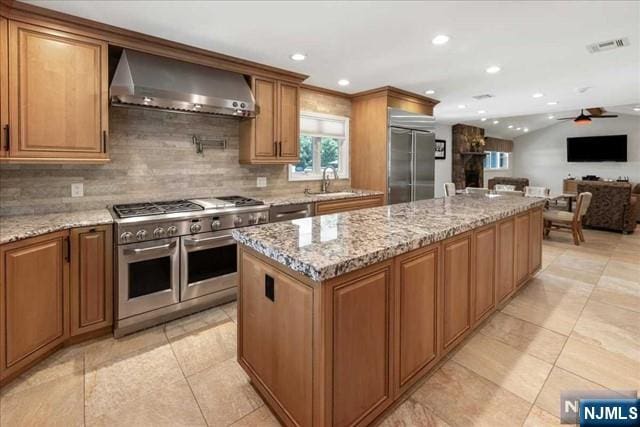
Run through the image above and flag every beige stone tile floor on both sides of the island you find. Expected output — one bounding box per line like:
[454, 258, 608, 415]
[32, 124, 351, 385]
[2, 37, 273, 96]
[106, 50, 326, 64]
[0, 231, 640, 427]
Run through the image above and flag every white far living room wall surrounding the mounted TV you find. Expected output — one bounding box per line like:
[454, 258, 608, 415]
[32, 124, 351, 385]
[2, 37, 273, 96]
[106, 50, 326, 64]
[512, 114, 640, 193]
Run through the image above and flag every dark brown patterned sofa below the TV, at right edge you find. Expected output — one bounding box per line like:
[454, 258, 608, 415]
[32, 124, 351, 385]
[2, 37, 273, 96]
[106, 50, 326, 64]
[578, 181, 639, 233]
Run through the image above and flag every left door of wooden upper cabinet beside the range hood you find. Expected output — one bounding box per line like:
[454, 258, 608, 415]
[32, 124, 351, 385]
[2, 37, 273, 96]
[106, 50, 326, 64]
[253, 78, 277, 159]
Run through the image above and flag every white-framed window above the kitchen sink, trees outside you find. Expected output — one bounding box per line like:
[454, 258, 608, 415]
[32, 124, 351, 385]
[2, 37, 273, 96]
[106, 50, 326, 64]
[289, 112, 349, 181]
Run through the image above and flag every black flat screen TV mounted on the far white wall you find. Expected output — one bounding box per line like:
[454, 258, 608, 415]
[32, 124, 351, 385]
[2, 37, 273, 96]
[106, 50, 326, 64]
[567, 135, 627, 162]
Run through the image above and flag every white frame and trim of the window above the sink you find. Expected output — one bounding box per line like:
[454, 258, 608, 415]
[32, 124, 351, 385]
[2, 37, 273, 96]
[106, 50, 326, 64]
[287, 111, 351, 181]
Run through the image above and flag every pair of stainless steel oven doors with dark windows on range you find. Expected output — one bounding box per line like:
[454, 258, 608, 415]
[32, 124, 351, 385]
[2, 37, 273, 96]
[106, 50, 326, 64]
[118, 231, 238, 319]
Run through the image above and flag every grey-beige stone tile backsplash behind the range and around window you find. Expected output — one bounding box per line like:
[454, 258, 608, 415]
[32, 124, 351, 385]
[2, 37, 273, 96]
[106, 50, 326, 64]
[0, 90, 351, 215]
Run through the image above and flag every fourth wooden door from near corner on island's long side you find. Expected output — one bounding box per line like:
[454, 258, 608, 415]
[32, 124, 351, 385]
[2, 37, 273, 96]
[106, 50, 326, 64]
[472, 224, 497, 325]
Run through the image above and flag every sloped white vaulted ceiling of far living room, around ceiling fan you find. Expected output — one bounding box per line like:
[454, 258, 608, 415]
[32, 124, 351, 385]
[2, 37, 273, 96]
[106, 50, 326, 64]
[462, 104, 640, 139]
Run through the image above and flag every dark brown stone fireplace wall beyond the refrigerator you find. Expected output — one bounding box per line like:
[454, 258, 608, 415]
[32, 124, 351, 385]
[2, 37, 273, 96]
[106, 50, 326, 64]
[451, 124, 484, 189]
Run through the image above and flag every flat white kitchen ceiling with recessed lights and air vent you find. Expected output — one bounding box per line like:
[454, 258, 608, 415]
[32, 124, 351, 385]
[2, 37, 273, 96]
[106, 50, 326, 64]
[30, 0, 640, 122]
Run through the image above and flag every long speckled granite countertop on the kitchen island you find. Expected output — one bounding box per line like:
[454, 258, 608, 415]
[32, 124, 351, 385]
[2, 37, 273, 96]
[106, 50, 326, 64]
[233, 195, 545, 281]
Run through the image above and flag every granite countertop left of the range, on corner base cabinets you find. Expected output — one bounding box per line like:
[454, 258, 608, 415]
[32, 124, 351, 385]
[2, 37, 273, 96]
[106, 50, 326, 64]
[0, 209, 113, 244]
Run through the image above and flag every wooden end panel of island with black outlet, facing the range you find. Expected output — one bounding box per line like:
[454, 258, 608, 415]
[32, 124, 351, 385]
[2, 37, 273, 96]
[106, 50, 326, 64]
[238, 252, 313, 426]
